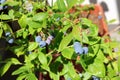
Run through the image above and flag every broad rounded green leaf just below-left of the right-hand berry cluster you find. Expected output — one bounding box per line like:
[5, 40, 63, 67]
[62, 47, 74, 59]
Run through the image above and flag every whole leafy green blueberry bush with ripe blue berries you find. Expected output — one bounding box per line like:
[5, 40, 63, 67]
[0, 0, 120, 80]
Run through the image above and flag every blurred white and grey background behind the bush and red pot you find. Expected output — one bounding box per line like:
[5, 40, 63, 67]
[48, 0, 120, 41]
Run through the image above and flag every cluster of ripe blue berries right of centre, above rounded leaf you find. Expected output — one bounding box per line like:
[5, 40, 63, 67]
[73, 42, 88, 54]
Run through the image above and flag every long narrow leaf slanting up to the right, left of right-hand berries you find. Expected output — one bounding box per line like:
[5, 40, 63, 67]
[58, 33, 73, 52]
